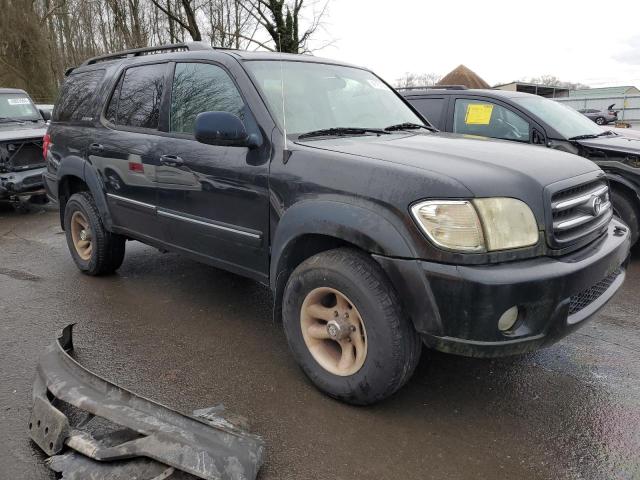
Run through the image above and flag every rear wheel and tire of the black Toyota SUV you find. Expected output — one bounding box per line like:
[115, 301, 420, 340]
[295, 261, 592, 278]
[64, 192, 126, 275]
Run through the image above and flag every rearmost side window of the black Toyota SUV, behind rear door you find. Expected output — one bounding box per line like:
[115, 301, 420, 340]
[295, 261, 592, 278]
[53, 70, 105, 122]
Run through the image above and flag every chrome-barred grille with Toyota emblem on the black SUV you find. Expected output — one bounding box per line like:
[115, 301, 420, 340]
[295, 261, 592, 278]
[551, 179, 613, 244]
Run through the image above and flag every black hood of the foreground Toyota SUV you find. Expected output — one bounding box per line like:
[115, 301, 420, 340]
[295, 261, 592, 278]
[297, 132, 600, 196]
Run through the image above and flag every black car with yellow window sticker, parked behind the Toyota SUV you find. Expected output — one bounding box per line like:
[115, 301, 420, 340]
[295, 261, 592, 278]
[401, 87, 640, 245]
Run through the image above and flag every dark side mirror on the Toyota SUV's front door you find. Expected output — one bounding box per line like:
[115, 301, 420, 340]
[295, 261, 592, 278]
[194, 112, 258, 148]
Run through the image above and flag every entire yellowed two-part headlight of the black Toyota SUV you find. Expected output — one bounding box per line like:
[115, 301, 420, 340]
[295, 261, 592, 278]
[411, 198, 538, 252]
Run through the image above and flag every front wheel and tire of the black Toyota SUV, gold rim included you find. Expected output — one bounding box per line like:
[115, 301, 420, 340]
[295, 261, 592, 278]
[282, 248, 422, 405]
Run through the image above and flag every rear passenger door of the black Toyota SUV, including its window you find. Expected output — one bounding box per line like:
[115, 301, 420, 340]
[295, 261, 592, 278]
[89, 63, 169, 239]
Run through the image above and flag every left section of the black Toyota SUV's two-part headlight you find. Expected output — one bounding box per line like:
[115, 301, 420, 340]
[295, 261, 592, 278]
[411, 200, 485, 252]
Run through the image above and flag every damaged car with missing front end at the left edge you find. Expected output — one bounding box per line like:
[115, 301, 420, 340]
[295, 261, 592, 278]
[0, 88, 48, 206]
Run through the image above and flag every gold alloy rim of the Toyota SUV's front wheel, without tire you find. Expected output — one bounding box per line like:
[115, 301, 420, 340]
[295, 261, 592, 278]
[300, 287, 367, 377]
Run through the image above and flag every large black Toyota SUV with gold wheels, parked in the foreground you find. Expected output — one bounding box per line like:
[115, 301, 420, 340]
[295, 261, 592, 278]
[45, 44, 629, 404]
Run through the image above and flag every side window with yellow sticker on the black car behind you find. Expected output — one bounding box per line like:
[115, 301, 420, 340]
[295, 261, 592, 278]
[453, 98, 531, 143]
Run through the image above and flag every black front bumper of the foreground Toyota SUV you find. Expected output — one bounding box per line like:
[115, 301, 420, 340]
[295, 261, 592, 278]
[375, 219, 630, 357]
